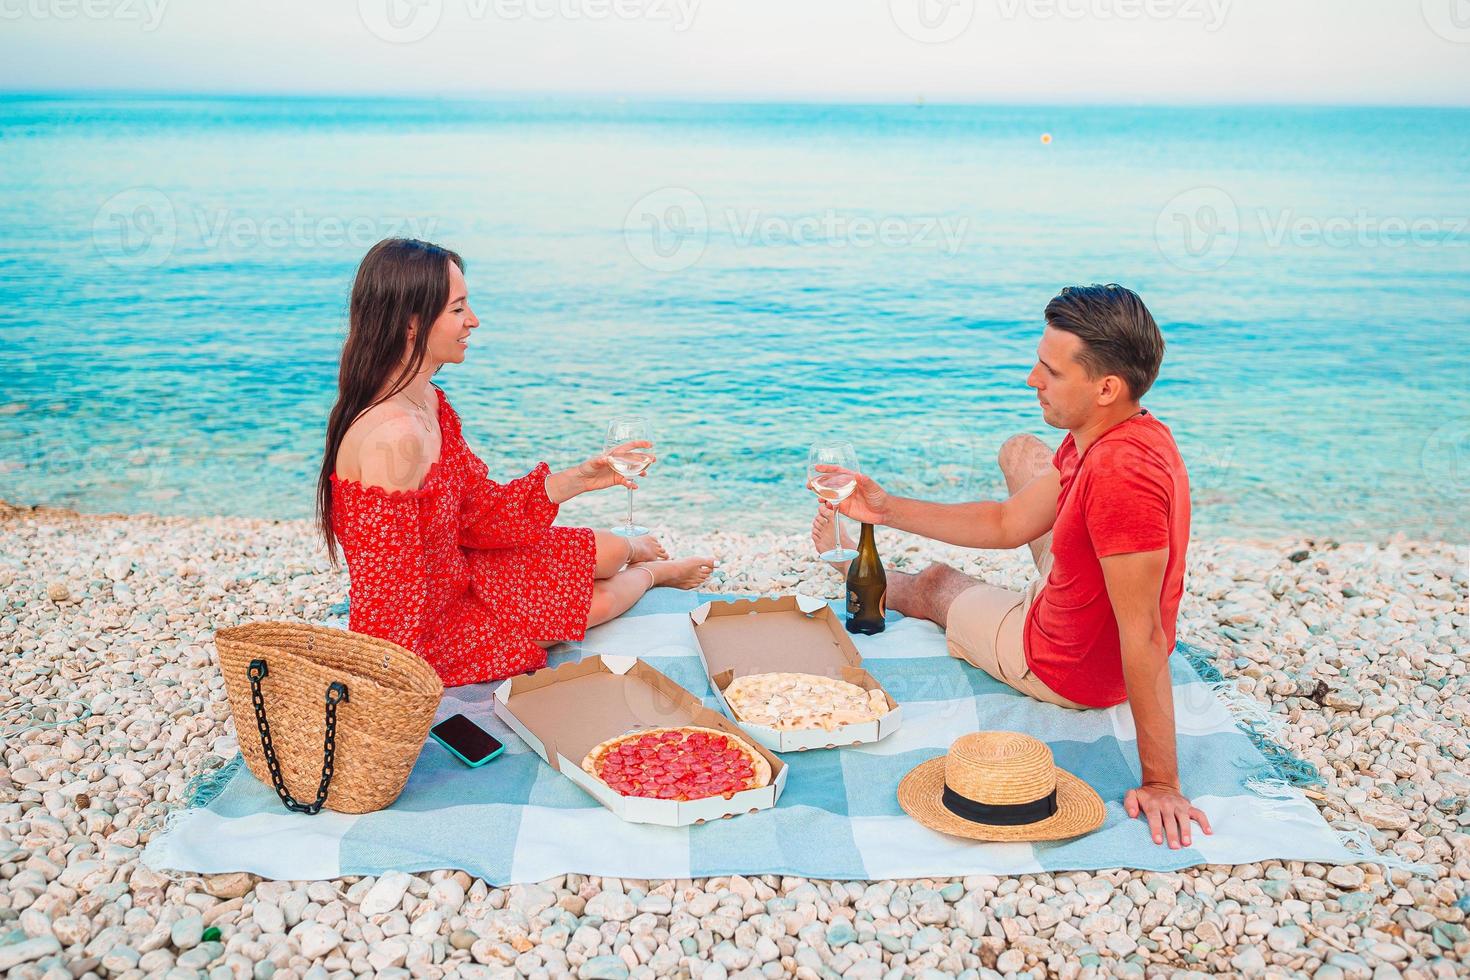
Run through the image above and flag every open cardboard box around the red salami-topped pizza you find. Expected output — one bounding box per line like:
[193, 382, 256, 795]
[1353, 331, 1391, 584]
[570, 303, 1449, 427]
[494, 655, 786, 827]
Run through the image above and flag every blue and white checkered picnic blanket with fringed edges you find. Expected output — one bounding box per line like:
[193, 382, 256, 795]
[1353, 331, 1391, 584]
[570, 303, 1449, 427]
[144, 589, 1372, 884]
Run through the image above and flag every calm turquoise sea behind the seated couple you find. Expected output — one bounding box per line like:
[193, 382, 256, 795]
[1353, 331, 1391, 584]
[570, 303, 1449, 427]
[0, 96, 1470, 541]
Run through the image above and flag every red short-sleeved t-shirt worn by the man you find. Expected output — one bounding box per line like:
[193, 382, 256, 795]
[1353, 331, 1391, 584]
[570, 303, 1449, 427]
[1025, 414, 1189, 708]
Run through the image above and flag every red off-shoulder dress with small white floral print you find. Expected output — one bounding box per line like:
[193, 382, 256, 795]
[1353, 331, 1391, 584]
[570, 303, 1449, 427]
[331, 385, 597, 688]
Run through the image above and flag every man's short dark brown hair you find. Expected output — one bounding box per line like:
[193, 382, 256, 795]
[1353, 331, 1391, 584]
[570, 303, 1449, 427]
[1047, 282, 1164, 400]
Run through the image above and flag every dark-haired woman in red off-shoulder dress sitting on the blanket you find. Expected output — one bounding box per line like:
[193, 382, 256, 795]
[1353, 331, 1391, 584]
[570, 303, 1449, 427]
[316, 238, 714, 686]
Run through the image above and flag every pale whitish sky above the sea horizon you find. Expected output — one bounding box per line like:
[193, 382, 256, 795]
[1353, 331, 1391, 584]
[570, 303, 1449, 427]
[0, 0, 1470, 106]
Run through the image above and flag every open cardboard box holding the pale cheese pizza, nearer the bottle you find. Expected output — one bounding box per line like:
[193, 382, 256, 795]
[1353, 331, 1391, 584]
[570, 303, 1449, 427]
[689, 595, 903, 752]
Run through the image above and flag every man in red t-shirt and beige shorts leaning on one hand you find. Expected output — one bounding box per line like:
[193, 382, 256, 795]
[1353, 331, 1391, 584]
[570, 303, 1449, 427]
[811, 285, 1210, 848]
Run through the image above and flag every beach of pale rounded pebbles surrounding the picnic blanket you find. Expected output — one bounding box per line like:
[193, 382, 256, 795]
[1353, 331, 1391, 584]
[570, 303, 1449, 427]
[0, 502, 1470, 980]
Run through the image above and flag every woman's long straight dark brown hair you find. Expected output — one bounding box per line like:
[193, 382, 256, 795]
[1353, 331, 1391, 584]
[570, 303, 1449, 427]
[316, 238, 465, 567]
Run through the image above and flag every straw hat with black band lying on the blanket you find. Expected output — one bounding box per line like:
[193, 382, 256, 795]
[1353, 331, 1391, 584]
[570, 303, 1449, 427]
[898, 732, 1105, 840]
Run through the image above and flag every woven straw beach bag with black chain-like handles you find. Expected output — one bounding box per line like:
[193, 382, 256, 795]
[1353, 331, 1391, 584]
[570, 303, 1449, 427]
[215, 621, 444, 814]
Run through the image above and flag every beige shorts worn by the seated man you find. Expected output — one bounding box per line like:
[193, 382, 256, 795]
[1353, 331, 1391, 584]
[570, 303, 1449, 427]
[945, 554, 1089, 710]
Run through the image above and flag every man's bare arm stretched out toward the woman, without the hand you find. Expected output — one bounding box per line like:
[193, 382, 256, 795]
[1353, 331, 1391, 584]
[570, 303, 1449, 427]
[883, 467, 1061, 550]
